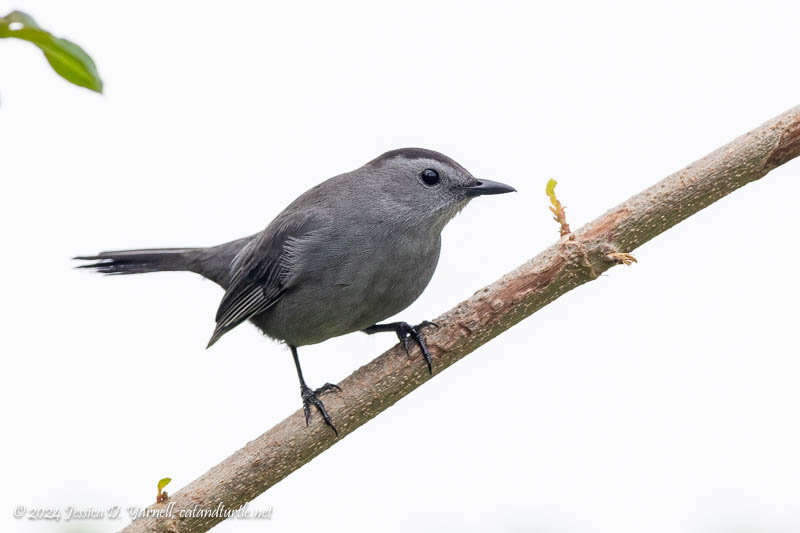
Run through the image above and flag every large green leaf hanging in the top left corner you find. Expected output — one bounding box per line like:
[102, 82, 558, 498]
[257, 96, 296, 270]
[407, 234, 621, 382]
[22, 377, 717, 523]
[0, 11, 103, 93]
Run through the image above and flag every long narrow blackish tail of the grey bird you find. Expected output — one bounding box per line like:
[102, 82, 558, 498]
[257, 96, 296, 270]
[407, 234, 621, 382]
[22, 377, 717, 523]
[73, 248, 202, 274]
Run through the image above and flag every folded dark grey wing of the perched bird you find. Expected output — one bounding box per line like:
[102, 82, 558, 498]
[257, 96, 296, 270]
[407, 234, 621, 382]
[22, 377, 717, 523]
[208, 213, 319, 346]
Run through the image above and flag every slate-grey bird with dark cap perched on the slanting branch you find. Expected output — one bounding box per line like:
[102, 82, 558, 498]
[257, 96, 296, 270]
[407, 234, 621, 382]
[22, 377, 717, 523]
[74, 148, 515, 437]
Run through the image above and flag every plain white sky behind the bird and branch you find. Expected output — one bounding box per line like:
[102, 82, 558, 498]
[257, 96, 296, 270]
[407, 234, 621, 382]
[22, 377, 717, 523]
[0, 1, 800, 533]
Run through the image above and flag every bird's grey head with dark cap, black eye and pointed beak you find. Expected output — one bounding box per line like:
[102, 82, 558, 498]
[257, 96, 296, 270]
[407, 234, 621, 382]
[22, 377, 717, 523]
[363, 148, 515, 231]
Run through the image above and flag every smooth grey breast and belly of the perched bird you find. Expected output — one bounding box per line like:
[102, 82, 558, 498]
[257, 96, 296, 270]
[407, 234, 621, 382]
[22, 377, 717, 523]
[256, 228, 441, 345]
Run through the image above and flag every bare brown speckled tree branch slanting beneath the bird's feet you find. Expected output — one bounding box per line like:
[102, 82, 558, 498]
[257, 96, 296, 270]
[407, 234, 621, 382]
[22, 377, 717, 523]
[119, 106, 800, 532]
